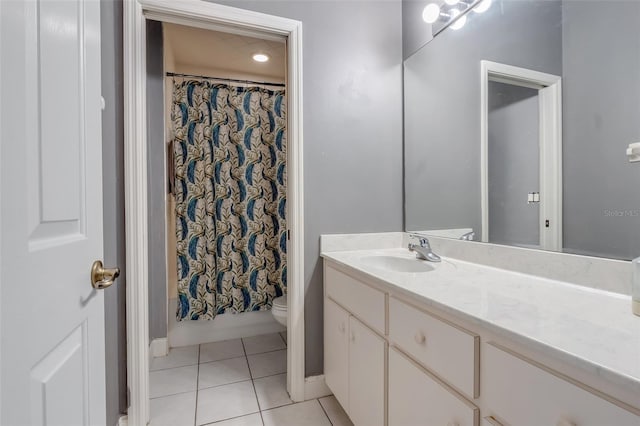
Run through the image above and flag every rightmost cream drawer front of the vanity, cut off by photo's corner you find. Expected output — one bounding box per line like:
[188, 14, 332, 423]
[482, 344, 640, 426]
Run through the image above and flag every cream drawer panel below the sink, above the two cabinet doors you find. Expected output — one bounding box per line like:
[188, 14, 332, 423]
[324, 266, 385, 335]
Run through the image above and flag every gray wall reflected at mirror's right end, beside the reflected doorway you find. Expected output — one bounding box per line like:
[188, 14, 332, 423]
[562, 1, 640, 259]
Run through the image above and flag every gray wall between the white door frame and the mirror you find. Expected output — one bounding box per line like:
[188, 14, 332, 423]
[208, 0, 402, 375]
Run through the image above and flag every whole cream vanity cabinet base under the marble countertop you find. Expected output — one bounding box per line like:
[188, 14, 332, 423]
[324, 261, 640, 426]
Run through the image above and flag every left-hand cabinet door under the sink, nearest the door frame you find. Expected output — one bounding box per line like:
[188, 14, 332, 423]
[324, 298, 349, 410]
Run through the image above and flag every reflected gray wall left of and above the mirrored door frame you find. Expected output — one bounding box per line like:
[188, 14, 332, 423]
[404, 0, 562, 236]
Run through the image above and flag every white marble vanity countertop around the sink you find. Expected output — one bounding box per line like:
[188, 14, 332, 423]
[322, 248, 640, 394]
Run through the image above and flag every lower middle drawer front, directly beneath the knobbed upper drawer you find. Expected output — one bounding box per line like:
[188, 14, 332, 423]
[389, 348, 479, 426]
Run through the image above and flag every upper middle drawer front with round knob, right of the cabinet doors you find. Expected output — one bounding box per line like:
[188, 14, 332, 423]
[389, 297, 480, 398]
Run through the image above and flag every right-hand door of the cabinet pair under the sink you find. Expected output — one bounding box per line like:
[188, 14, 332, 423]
[348, 317, 386, 426]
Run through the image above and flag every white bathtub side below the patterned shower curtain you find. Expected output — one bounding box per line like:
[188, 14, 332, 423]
[168, 299, 286, 348]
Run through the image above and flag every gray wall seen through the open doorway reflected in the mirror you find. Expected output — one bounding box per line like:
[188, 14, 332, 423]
[487, 81, 540, 247]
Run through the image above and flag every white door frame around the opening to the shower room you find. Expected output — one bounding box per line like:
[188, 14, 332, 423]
[123, 0, 305, 425]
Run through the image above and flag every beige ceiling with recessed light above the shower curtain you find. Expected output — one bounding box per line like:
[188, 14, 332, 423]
[163, 23, 286, 81]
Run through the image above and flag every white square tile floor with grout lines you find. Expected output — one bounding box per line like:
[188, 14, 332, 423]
[149, 333, 352, 426]
